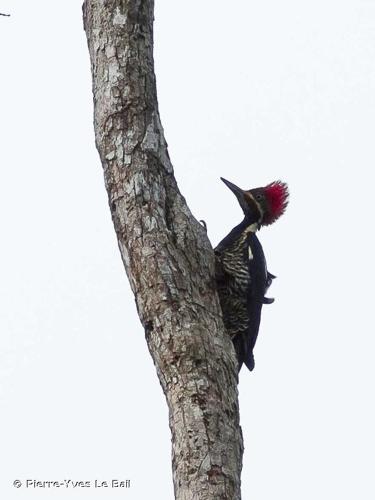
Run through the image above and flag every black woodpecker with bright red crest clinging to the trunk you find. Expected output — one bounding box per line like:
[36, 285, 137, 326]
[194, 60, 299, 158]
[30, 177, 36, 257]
[215, 177, 289, 371]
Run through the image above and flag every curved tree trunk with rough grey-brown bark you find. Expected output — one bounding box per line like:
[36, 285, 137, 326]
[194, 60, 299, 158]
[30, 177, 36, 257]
[83, 0, 243, 500]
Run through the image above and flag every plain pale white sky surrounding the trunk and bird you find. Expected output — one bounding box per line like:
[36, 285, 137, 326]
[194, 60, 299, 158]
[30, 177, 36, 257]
[0, 0, 375, 500]
